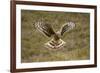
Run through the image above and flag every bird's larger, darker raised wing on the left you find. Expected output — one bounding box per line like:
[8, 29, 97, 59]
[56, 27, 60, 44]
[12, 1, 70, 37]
[35, 21, 55, 37]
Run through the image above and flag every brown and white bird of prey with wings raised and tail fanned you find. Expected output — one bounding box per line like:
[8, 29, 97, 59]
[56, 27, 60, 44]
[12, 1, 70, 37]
[35, 21, 75, 49]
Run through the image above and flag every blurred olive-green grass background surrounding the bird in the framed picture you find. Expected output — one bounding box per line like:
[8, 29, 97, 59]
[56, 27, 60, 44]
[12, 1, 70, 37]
[21, 10, 90, 62]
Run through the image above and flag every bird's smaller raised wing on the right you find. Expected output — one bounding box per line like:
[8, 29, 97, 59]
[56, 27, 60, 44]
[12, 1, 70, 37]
[60, 22, 75, 35]
